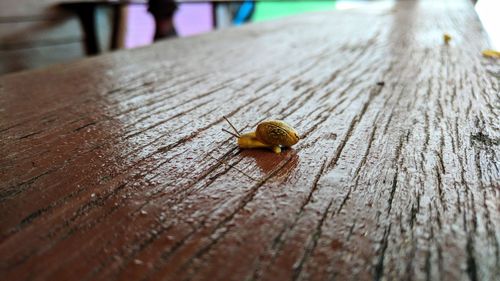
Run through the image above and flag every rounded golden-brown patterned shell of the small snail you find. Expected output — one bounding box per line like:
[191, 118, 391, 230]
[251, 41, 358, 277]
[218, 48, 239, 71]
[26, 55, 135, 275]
[255, 120, 299, 147]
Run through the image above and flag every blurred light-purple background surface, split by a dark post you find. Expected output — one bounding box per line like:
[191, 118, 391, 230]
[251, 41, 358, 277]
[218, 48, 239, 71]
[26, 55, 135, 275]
[125, 3, 213, 48]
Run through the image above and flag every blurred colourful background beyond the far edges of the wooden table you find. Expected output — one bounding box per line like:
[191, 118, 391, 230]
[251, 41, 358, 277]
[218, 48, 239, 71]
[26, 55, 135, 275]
[0, 0, 500, 75]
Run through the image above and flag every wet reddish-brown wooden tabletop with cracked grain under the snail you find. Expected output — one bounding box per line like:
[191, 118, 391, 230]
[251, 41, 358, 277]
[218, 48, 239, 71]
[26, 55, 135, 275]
[0, 1, 500, 280]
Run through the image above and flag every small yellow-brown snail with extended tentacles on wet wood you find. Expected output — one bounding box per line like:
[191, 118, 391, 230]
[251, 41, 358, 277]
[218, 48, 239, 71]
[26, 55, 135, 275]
[222, 117, 299, 154]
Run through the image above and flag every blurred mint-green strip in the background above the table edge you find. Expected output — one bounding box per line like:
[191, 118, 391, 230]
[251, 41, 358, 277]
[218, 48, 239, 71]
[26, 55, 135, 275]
[252, 0, 335, 22]
